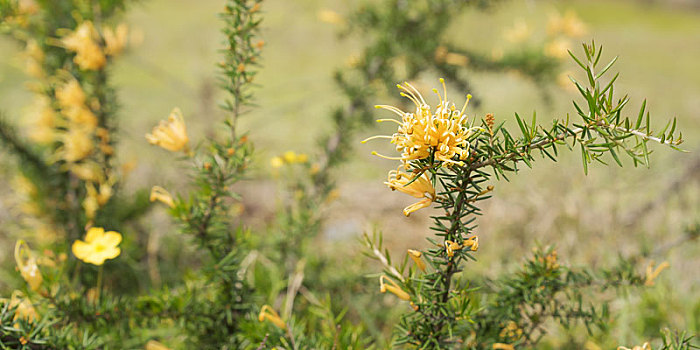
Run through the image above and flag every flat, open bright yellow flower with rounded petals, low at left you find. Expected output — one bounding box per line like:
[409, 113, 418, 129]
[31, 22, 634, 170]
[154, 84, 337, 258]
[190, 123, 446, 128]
[72, 227, 122, 265]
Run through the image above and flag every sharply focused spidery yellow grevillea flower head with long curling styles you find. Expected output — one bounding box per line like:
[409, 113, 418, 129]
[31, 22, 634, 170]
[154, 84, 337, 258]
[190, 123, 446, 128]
[362, 79, 477, 165]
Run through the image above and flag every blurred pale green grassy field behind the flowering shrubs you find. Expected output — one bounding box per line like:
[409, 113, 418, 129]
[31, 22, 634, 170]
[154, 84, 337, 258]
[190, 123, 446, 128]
[0, 0, 700, 342]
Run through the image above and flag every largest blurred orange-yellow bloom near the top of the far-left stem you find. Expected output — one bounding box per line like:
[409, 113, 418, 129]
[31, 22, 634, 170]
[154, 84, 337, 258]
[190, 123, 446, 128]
[61, 21, 107, 70]
